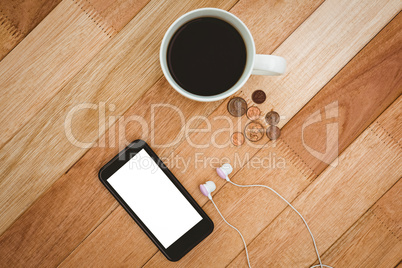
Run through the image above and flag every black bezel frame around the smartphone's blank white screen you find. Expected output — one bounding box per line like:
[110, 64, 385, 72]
[98, 140, 214, 261]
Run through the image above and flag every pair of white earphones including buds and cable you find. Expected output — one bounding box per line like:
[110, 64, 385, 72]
[200, 164, 332, 268]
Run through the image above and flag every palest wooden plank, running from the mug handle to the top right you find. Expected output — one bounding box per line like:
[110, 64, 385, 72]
[245, 0, 402, 130]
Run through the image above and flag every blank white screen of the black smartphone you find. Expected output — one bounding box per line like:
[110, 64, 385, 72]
[107, 149, 202, 248]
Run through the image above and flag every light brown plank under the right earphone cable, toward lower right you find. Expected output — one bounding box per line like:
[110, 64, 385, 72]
[230, 98, 402, 267]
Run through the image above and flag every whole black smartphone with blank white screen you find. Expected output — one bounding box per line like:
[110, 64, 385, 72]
[99, 140, 214, 261]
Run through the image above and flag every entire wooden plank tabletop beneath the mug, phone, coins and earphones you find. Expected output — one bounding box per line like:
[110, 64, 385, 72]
[0, 0, 402, 267]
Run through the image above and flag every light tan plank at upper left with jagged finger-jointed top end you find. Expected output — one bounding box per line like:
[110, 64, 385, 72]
[0, 0, 115, 147]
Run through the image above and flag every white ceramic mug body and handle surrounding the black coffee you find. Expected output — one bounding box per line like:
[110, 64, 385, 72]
[159, 8, 286, 102]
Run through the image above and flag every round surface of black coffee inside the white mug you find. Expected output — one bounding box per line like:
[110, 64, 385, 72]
[167, 17, 247, 96]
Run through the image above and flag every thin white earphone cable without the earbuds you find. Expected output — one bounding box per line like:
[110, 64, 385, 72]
[210, 179, 333, 268]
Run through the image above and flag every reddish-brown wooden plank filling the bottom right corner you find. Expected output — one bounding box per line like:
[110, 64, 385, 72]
[314, 179, 402, 267]
